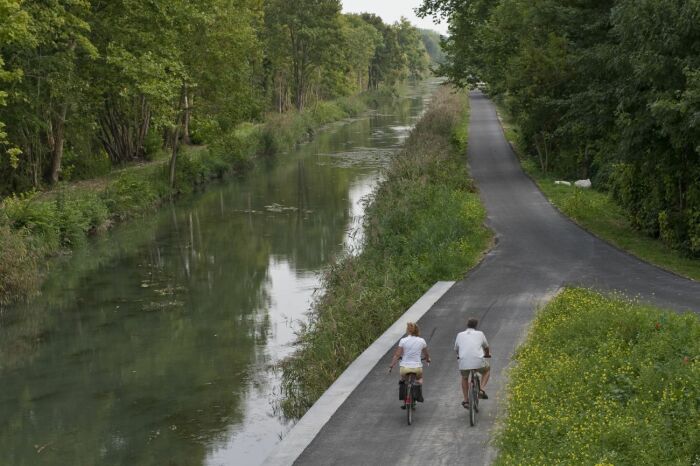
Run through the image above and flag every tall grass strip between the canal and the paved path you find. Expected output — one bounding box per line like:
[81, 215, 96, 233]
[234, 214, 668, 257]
[282, 87, 491, 417]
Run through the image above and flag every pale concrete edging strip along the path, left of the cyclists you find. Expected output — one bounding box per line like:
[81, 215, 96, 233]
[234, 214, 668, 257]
[263, 281, 455, 466]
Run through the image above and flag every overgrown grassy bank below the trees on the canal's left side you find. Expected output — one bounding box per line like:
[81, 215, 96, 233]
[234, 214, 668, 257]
[0, 95, 370, 306]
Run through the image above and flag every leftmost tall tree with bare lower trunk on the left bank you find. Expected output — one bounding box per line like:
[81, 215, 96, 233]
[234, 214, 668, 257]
[0, 0, 97, 185]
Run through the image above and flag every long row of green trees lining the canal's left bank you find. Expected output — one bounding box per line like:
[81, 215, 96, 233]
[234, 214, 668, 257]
[0, 0, 428, 196]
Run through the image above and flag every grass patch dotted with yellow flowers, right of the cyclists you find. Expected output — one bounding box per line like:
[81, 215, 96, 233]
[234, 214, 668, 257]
[495, 289, 700, 465]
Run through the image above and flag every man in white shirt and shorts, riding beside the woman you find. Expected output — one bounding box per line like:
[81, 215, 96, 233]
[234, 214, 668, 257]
[455, 317, 491, 408]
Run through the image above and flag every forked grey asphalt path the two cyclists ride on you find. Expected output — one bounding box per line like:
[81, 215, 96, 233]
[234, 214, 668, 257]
[278, 92, 700, 465]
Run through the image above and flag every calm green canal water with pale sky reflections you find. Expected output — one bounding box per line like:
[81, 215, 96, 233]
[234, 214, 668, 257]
[0, 78, 438, 465]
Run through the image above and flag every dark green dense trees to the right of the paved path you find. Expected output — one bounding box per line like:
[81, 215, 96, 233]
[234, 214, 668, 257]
[422, 0, 700, 256]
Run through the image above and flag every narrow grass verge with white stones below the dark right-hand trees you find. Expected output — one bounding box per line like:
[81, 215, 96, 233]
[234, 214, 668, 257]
[499, 109, 700, 280]
